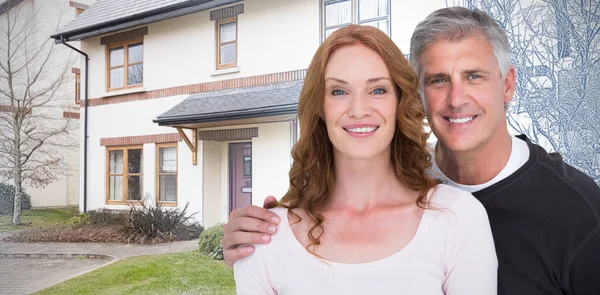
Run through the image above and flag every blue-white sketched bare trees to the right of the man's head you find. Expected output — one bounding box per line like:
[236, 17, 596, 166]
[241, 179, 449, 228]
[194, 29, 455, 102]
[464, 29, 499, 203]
[447, 0, 600, 184]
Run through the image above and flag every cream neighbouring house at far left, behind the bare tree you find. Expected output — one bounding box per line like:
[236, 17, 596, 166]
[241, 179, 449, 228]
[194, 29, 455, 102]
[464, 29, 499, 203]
[0, 0, 93, 208]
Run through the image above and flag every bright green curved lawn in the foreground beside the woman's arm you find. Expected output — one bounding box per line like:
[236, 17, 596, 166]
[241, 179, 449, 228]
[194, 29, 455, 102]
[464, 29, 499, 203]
[35, 251, 235, 295]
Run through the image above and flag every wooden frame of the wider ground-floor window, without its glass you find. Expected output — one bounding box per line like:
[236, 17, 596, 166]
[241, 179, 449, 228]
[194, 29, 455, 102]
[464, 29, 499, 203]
[105, 145, 144, 204]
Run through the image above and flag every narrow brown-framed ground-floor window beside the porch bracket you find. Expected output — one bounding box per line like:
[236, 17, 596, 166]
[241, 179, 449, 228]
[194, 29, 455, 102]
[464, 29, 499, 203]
[156, 143, 177, 204]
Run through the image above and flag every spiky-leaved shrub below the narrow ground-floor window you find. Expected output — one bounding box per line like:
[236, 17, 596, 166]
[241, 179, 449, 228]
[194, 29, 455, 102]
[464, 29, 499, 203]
[122, 201, 204, 244]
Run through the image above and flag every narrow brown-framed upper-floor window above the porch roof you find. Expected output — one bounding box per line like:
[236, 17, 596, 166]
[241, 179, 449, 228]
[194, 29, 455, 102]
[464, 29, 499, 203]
[217, 17, 237, 69]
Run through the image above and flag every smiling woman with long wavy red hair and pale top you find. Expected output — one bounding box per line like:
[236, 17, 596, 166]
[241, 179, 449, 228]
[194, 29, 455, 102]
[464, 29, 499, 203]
[234, 26, 497, 295]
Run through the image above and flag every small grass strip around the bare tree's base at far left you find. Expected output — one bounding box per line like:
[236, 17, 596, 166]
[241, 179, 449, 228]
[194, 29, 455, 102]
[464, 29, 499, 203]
[0, 209, 78, 233]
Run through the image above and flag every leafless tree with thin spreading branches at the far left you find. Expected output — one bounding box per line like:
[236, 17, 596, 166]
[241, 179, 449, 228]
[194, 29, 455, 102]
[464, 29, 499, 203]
[0, 0, 76, 225]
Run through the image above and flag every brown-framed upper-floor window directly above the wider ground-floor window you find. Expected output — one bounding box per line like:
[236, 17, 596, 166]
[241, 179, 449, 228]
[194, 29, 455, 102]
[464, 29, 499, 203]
[106, 39, 144, 91]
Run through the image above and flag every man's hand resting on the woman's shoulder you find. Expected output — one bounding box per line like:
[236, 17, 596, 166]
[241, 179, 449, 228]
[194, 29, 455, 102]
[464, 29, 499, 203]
[222, 196, 280, 267]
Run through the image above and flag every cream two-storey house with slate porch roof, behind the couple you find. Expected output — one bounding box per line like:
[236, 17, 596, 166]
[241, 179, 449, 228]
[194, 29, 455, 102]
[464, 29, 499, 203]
[52, 0, 460, 226]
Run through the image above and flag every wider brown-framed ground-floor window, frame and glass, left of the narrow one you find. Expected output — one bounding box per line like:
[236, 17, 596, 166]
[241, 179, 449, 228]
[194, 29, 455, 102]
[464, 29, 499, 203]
[106, 146, 143, 203]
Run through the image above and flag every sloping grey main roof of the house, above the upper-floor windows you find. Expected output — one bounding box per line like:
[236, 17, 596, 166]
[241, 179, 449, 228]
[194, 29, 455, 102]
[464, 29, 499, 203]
[50, 0, 242, 42]
